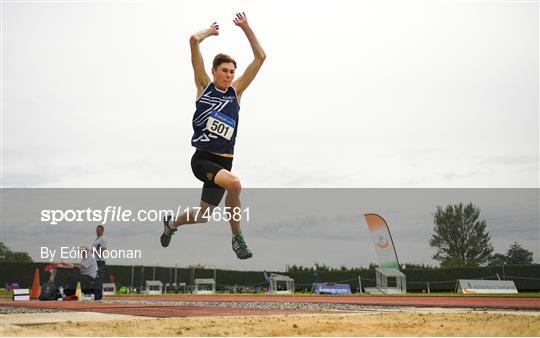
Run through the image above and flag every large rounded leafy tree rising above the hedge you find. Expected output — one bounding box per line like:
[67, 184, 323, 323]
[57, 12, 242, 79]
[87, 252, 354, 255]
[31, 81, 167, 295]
[429, 203, 493, 267]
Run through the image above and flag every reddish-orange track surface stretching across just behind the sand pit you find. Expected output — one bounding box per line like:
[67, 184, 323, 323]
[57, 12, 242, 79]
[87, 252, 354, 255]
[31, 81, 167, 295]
[0, 295, 540, 318]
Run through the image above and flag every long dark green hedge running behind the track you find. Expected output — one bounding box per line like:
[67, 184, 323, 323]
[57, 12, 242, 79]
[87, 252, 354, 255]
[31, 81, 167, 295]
[0, 262, 540, 292]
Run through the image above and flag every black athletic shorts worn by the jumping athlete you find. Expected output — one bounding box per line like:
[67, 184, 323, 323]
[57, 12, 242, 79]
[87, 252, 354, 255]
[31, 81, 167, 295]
[191, 149, 233, 206]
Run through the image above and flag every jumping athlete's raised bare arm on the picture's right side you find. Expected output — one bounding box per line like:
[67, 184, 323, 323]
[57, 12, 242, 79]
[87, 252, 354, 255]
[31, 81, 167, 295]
[232, 13, 266, 97]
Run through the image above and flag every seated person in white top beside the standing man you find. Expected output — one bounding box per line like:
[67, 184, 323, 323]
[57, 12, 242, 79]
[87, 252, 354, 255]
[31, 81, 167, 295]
[58, 246, 98, 296]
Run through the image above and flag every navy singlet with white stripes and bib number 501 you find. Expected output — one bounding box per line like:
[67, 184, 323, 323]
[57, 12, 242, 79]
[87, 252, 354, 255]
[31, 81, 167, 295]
[191, 83, 240, 154]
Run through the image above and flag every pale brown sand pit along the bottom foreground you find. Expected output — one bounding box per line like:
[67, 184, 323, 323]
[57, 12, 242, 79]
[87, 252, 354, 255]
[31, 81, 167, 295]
[2, 311, 540, 336]
